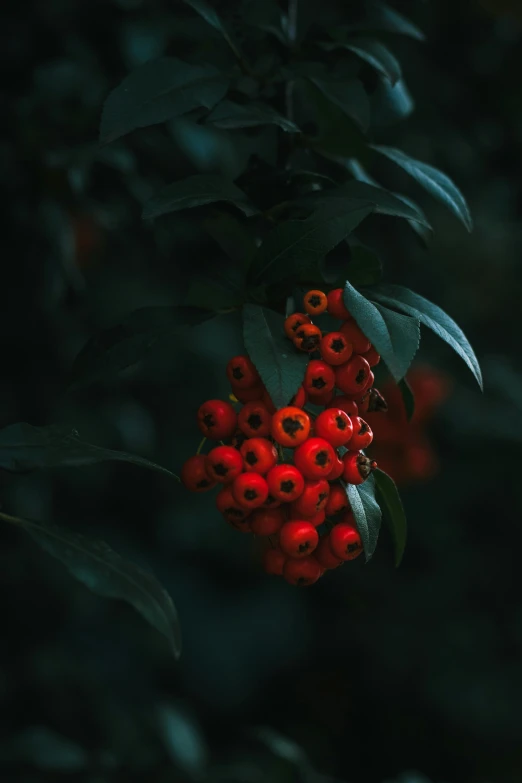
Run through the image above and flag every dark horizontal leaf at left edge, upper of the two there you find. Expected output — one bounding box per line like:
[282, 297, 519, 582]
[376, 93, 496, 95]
[0, 422, 179, 480]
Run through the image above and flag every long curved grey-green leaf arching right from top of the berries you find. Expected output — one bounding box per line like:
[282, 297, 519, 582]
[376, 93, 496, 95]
[369, 285, 483, 389]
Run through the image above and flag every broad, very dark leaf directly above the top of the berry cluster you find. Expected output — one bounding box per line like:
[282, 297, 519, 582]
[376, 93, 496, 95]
[252, 199, 371, 283]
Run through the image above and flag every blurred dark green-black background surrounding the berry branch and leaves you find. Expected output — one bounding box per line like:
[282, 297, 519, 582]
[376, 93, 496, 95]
[0, 0, 522, 783]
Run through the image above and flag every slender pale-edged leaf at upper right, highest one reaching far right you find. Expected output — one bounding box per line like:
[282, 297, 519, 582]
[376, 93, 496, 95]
[370, 145, 473, 231]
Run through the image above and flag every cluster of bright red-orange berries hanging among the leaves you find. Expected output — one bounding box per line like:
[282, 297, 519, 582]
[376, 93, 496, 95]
[181, 288, 386, 585]
